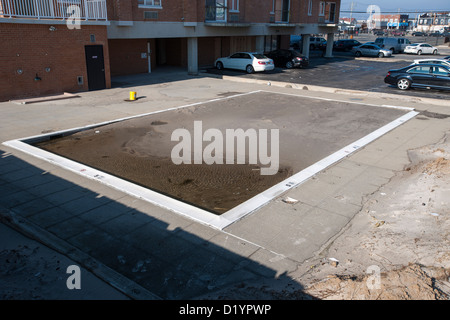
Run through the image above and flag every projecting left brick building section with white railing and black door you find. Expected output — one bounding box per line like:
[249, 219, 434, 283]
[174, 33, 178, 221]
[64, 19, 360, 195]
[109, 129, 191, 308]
[0, 0, 111, 101]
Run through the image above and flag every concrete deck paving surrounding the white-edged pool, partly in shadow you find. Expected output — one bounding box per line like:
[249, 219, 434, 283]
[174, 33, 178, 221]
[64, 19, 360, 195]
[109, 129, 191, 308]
[0, 71, 450, 299]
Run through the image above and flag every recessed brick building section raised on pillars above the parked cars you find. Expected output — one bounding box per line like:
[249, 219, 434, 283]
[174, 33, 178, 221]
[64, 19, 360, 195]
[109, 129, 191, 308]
[108, 0, 340, 75]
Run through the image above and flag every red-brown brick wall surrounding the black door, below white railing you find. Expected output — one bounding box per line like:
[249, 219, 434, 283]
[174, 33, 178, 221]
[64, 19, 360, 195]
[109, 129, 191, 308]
[0, 23, 111, 101]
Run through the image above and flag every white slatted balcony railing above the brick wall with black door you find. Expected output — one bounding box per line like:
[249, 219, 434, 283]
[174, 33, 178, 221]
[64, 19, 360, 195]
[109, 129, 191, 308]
[0, 0, 108, 20]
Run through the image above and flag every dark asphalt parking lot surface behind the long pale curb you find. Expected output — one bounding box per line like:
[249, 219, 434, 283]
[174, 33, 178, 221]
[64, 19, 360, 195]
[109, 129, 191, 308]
[208, 36, 450, 99]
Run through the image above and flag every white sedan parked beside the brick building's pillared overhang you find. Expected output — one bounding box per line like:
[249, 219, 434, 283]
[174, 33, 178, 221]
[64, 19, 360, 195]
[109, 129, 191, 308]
[214, 52, 275, 73]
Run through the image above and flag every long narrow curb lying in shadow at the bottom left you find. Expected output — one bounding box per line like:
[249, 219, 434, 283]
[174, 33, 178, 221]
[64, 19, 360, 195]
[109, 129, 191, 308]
[0, 207, 162, 300]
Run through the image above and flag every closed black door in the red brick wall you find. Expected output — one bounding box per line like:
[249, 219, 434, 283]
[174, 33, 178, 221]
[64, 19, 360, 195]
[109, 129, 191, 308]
[84, 45, 106, 91]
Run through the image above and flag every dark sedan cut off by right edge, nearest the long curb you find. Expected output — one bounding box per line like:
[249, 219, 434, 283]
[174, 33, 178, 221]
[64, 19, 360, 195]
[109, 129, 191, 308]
[384, 64, 450, 90]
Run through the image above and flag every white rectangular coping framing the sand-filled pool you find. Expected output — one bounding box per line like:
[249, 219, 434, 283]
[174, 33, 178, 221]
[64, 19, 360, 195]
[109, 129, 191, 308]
[3, 90, 418, 230]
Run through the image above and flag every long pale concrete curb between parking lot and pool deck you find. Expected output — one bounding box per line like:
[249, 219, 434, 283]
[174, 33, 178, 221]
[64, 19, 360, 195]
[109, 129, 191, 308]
[221, 75, 448, 106]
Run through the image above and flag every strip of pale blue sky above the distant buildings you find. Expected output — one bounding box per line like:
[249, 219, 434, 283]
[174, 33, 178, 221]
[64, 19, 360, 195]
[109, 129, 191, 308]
[340, 0, 450, 19]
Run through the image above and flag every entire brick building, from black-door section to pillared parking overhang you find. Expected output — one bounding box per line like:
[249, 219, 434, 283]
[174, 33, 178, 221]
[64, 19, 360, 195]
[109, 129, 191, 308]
[0, 0, 340, 101]
